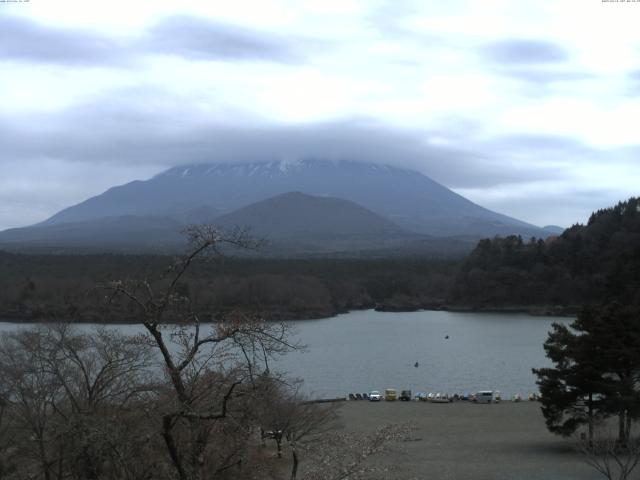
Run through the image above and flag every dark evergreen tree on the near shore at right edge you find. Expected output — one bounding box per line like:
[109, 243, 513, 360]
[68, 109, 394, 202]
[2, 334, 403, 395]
[533, 304, 640, 443]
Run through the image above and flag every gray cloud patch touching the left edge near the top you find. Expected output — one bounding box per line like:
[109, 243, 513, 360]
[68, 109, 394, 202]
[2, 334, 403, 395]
[0, 16, 125, 65]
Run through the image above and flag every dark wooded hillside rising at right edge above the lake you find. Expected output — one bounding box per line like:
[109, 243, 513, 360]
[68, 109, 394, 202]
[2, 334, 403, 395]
[451, 198, 640, 308]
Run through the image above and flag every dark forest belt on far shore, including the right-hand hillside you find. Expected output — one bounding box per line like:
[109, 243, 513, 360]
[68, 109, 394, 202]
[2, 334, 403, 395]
[0, 198, 640, 321]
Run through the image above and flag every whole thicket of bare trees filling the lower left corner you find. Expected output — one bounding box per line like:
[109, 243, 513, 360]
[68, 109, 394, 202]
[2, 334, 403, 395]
[0, 325, 158, 479]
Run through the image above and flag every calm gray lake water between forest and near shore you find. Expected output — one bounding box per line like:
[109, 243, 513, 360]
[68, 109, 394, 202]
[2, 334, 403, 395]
[0, 310, 572, 398]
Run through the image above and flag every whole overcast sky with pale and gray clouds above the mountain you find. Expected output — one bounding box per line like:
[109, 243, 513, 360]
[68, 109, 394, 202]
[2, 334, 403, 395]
[0, 0, 640, 230]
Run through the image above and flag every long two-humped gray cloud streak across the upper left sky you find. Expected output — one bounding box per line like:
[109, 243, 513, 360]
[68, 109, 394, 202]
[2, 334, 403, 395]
[0, 16, 310, 66]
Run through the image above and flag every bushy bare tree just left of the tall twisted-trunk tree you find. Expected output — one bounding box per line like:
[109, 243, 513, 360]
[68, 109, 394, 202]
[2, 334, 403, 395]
[40, 324, 157, 479]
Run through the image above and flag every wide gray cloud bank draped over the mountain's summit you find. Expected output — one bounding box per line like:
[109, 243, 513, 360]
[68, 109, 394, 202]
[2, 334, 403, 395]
[0, 89, 635, 229]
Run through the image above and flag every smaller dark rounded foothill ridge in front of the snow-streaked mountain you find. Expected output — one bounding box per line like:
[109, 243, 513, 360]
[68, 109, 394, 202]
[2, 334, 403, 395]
[0, 192, 473, 257]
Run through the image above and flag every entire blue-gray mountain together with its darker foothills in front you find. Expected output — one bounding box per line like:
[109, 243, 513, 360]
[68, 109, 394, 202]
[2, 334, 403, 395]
[0, 160, 556, 256]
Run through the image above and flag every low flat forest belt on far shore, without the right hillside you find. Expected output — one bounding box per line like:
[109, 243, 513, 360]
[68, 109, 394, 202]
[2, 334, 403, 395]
[0, 252, 457, 321]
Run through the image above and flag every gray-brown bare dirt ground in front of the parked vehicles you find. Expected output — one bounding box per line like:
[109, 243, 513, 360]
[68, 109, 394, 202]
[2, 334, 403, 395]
[339, 401, 603, 480]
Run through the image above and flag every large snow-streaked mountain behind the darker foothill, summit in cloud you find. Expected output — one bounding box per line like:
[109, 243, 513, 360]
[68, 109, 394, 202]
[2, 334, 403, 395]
[36, 160, 547, 238]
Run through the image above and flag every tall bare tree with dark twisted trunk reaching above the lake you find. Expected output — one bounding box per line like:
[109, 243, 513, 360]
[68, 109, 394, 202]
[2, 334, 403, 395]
[107, 226, 295, 480]
